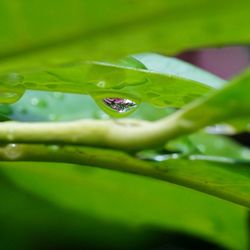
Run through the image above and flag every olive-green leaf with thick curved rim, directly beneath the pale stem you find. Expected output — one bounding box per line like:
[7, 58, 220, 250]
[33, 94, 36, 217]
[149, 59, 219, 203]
[0, 144, 250, 207]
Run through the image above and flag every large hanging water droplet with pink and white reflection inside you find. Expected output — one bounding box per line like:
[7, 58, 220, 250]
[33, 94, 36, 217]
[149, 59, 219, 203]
[92, 92, 139, 118]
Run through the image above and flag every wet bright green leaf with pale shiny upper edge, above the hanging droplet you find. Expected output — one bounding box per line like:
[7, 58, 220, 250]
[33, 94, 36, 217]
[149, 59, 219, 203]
[0, 55, 223, 107]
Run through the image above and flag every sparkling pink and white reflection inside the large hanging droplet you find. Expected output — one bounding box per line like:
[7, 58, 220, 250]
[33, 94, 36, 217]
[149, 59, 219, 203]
[103, 98, 137, 113]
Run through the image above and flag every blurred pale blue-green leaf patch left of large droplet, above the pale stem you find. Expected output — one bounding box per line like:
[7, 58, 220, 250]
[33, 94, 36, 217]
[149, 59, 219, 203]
[4, 91, 107, 121]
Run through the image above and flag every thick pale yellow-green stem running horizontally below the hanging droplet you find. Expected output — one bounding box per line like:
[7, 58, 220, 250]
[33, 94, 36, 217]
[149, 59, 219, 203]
[0, 112, 202, 151]
